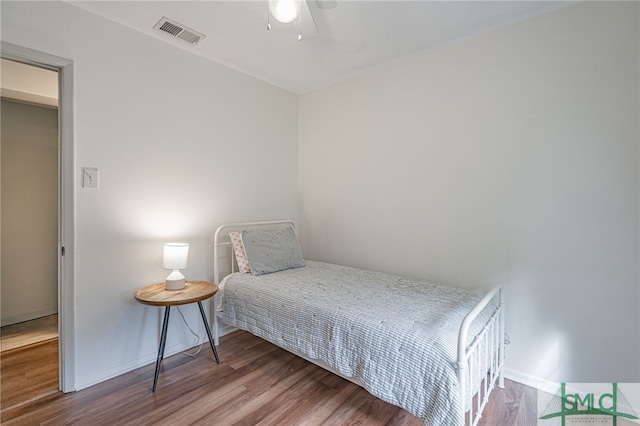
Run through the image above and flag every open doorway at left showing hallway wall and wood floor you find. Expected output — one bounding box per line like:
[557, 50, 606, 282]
[0, 59, 60, 411]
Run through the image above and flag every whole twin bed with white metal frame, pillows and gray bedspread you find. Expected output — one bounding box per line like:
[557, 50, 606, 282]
[213, 221, 505, 425]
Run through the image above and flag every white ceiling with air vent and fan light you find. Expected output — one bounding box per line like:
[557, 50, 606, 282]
[69, 0, 575, 93]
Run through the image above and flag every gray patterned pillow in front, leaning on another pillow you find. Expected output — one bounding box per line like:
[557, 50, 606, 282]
[242, 228, 304, 275]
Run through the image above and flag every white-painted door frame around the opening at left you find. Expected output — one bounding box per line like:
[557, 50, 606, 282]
[0, 41, 76, 392]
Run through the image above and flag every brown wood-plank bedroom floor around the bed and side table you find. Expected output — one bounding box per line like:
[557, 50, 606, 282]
[1, 332, 536, 426]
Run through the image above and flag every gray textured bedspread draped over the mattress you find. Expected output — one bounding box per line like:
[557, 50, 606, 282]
[221, 261, 481, 425]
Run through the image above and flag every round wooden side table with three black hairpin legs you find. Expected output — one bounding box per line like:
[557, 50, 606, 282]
[133, 281, 220, 392]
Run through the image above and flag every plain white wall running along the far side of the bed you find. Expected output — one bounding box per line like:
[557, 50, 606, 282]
[299, 2, 640, 385]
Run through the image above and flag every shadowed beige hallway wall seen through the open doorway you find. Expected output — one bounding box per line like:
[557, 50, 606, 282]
[0, 100, 58, 326]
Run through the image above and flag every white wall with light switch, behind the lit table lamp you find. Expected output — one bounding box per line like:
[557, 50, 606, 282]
[1, 1, 299, 389]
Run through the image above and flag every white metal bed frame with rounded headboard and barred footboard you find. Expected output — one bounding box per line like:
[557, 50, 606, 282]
[212, 220, 505, 426]
